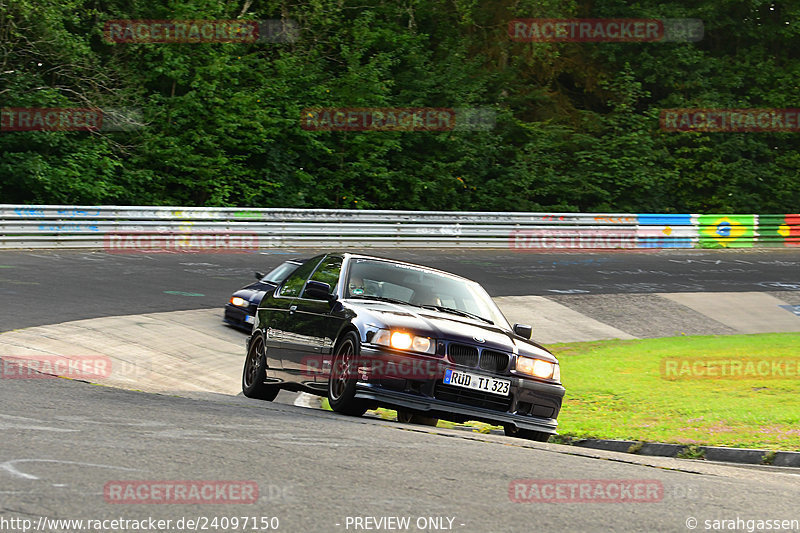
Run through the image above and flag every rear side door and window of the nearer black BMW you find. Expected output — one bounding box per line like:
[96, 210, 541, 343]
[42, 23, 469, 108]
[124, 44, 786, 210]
[258, 255, 325, 370]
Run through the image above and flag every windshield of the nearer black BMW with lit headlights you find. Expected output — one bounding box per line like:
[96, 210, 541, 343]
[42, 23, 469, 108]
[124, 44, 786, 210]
[346, 259, 510, 328]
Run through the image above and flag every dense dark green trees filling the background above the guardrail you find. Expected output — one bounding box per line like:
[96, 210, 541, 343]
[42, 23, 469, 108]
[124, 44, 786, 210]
[0, 0, 800, 213]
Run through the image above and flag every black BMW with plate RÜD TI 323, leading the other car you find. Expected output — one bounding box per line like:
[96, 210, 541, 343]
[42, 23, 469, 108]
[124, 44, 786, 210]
[242, 253, 564, 441]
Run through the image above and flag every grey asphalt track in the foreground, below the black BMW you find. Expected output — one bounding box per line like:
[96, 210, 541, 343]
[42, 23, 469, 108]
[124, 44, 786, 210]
[0, 372, 800, 532]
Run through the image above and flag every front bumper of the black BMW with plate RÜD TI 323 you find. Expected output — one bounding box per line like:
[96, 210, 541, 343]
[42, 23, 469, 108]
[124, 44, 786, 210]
[356, 346, 565, 434]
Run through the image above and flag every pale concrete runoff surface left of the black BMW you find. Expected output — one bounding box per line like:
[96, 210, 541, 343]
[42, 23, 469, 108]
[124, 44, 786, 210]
[0, 309, 247, 395]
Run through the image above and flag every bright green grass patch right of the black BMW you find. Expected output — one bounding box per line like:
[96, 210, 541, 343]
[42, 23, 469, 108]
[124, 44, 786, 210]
[549, 333, 800, 450]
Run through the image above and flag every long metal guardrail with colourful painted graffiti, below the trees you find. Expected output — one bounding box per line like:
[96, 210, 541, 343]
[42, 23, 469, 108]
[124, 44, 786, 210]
[0, 204, 800, 252]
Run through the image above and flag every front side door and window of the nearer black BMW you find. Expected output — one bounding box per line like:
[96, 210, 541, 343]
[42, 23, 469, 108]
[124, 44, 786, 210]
[281, 255, 344, 386]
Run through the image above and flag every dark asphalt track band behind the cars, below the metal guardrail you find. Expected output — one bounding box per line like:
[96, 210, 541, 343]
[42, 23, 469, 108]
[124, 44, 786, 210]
[0, 249, 800, 331]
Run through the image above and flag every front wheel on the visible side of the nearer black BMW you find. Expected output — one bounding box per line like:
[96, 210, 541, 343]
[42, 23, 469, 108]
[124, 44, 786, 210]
[328, 331, 367, 416]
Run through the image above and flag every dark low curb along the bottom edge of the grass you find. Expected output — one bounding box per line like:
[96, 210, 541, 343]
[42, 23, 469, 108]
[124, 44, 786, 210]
[562, 438, 800, 467]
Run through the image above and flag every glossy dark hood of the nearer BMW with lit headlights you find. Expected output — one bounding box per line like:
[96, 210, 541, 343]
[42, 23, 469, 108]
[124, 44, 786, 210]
[348, 300, 556, 362]
